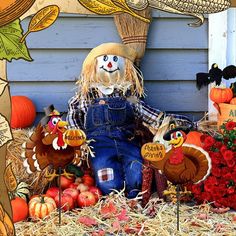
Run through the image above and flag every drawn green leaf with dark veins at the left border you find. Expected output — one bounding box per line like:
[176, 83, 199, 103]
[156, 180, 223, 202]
[0, 19, 32, 62]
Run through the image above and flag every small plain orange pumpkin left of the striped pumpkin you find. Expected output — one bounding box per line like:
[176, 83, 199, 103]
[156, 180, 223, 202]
[11, 197, 29, 223]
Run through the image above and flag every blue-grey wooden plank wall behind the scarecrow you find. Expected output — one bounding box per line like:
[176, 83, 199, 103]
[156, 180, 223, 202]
[7, 11, 208, 123]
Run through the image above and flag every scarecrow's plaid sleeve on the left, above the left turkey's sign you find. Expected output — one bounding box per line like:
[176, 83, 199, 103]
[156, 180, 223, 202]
[66, 95, 84, 129]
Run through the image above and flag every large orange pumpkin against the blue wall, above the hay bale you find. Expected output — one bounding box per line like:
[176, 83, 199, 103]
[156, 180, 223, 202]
[11, 96, 36, 128]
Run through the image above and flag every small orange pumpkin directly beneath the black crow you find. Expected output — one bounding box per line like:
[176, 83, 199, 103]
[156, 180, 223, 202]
[210, 88, 233, 103]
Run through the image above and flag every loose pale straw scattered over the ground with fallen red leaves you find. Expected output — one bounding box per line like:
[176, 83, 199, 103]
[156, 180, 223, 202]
[15, 193, 236, 236]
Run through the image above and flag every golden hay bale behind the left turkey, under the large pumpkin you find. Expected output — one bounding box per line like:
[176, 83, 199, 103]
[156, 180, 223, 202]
[6, 129, 48, 195]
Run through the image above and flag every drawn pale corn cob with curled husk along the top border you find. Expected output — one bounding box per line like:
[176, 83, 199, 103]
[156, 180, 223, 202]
[126, 0, 231, 26]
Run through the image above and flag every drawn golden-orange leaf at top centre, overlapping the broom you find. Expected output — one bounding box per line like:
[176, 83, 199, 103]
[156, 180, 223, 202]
[78, 0, 150, 23]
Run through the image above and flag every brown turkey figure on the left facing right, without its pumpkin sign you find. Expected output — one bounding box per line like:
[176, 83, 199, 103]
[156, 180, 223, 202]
[22, 105, 79, 180]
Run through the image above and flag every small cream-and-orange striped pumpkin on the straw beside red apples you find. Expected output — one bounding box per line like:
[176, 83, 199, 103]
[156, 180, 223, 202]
[29, 196, 57, 219]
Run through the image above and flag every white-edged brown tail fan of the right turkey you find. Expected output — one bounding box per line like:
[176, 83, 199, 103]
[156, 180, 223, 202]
[182, 144, 211, 184]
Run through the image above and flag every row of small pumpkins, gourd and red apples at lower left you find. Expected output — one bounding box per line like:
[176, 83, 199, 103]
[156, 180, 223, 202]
[11, 174, 102, 223]
